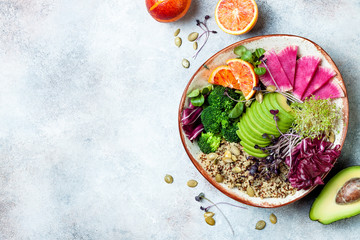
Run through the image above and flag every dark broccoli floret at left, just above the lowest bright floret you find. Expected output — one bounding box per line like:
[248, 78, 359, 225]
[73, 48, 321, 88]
[200, 106, 222, 133]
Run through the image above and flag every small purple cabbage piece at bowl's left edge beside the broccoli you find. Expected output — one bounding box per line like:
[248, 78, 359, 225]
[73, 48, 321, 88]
[181, 103, 204, 141]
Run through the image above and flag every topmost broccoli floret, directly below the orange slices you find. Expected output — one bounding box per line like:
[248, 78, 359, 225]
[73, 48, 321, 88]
[207, 85, 240, 111]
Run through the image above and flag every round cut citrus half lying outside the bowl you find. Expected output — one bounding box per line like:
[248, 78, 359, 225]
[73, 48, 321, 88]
[215, 0, 258, 35]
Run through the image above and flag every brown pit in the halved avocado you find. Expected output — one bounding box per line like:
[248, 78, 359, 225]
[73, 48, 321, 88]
[335, 178, 360, 204]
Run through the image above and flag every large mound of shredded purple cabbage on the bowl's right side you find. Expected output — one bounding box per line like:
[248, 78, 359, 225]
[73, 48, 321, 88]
[285, 136, 340, 190]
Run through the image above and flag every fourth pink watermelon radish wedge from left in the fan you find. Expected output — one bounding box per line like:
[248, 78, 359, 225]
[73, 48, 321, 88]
[301, 67, 336, 100]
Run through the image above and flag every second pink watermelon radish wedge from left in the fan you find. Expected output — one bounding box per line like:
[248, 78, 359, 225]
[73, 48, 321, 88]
[277, 46, 298, 86]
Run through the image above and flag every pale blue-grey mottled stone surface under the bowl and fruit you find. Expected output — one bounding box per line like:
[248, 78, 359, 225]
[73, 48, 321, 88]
[0, 0, 360, 240]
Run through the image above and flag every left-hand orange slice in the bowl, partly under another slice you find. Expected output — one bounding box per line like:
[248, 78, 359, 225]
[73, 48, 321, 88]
[208, 65, 240, 89]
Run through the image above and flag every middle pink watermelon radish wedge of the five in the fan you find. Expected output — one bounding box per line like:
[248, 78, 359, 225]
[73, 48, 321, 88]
[293, 56, 320, 99]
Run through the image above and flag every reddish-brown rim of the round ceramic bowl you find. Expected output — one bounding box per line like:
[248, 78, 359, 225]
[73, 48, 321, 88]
[178, 34, 349, 208]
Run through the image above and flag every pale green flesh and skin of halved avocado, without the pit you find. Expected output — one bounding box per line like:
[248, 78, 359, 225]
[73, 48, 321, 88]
[310, 166, 360, 224]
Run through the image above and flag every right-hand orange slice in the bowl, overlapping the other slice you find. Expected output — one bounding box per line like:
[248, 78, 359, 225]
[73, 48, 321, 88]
[226, 58, 259, 100]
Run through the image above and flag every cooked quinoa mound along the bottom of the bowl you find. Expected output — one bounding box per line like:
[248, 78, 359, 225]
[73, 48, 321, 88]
[199, 140, 297, 198]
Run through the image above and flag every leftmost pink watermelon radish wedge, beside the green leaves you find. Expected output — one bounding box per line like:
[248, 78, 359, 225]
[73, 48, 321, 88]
[259, 50, 292, 92]
